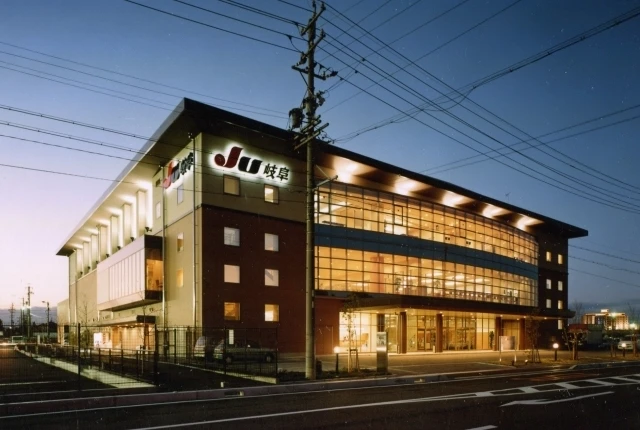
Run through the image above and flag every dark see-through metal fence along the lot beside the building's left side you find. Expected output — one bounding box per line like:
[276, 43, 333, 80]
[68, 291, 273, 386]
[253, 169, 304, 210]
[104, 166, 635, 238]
[0, 325, 278, 396]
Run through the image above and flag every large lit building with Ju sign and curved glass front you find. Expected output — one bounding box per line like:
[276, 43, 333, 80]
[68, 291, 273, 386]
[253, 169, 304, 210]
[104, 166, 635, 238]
[58, 99, 587, 354]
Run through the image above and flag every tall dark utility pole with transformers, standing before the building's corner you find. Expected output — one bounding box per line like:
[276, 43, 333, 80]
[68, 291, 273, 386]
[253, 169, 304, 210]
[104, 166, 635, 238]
[289, 0, 337, 380]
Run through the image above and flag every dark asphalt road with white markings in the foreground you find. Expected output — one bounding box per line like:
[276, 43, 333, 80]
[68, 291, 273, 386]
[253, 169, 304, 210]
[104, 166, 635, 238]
[5, 366, 640, 430]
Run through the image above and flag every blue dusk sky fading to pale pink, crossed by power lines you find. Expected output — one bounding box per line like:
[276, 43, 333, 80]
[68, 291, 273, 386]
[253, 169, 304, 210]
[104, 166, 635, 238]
[0, 0, 640, 311]
